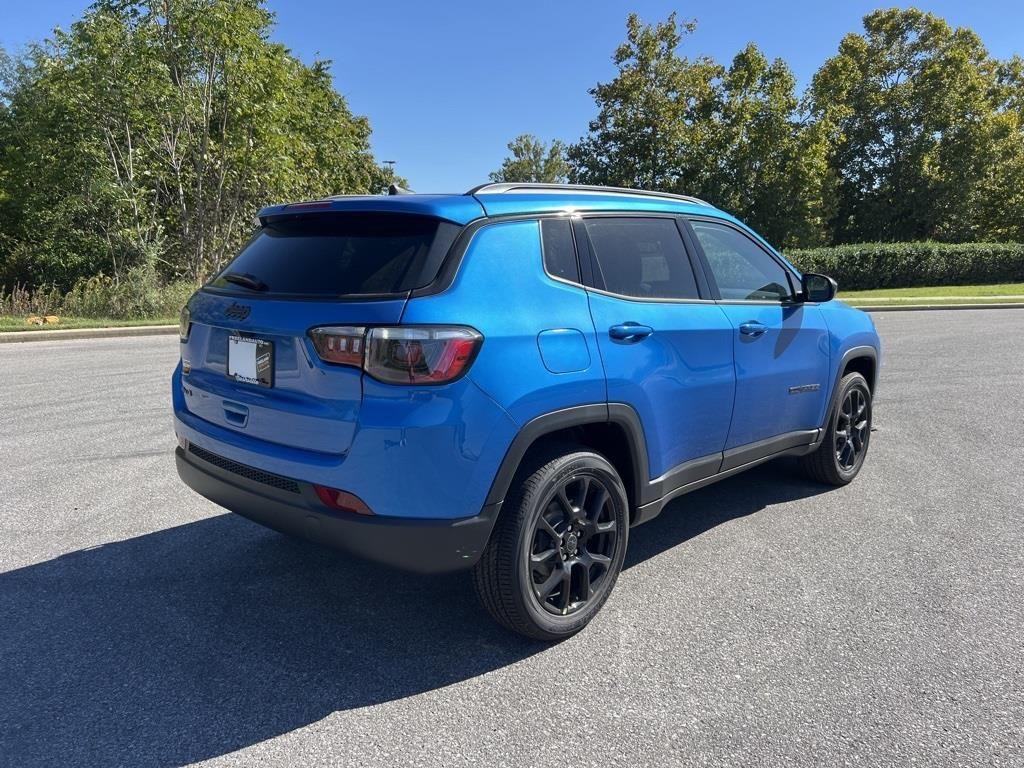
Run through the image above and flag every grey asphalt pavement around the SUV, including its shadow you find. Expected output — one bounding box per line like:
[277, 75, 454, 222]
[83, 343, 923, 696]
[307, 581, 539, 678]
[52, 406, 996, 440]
[0, 310, 1024, 767]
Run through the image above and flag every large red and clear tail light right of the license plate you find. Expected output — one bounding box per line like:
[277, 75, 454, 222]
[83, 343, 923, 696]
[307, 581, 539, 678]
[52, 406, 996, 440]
[309, 326, 483, 384]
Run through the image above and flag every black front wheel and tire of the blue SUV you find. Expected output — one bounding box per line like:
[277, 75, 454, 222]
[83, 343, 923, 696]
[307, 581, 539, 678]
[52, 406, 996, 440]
[801, 373, 871, 485]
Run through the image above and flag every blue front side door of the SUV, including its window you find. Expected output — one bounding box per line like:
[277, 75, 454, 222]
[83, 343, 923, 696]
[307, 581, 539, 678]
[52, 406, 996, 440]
[689, 218, 829, 451]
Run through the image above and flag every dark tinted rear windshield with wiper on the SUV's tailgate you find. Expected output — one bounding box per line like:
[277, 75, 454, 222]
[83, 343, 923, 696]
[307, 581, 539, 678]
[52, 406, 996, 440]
[210, 213, 459, 296]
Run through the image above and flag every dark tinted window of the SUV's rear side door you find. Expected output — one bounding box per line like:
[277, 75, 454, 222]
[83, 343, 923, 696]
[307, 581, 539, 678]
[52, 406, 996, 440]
[586, 218, 698, 299]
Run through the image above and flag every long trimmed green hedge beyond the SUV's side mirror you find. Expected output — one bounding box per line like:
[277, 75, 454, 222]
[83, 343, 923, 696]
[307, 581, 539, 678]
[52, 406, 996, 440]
[785, 243, 1024, 291]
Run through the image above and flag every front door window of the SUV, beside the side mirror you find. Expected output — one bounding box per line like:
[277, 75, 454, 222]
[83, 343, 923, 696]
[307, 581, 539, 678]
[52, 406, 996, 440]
[690, 221, 793, 301]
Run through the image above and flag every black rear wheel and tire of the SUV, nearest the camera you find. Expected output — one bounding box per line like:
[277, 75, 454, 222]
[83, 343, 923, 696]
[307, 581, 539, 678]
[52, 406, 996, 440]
[472, 447, 629, 641]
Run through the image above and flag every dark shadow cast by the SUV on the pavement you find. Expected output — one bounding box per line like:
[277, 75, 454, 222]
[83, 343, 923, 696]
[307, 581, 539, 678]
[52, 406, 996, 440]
[0, 460, 820, 766]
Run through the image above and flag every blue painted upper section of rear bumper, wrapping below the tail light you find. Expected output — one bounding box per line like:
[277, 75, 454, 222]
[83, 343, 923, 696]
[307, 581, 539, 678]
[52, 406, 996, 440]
[171, 362, 518, 522]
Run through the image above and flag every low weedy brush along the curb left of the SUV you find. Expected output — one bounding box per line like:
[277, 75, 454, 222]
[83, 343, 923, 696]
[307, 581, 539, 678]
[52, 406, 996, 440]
[0, 267, 196, 319]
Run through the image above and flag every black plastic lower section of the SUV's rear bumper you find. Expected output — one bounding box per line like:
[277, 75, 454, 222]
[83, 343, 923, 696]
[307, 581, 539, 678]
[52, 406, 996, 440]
[175, 447, 501, 573]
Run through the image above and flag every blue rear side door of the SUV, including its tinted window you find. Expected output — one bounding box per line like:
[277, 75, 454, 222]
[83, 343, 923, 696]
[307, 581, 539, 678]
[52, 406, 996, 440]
[577, 216, 734, 486]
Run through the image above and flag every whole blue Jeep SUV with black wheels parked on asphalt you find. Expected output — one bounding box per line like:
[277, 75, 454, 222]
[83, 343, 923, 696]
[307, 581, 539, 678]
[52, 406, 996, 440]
[171, 183, 880, 640]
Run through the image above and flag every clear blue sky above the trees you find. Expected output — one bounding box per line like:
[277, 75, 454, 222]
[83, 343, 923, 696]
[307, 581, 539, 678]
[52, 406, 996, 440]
[6, 0, 1024, 191]
